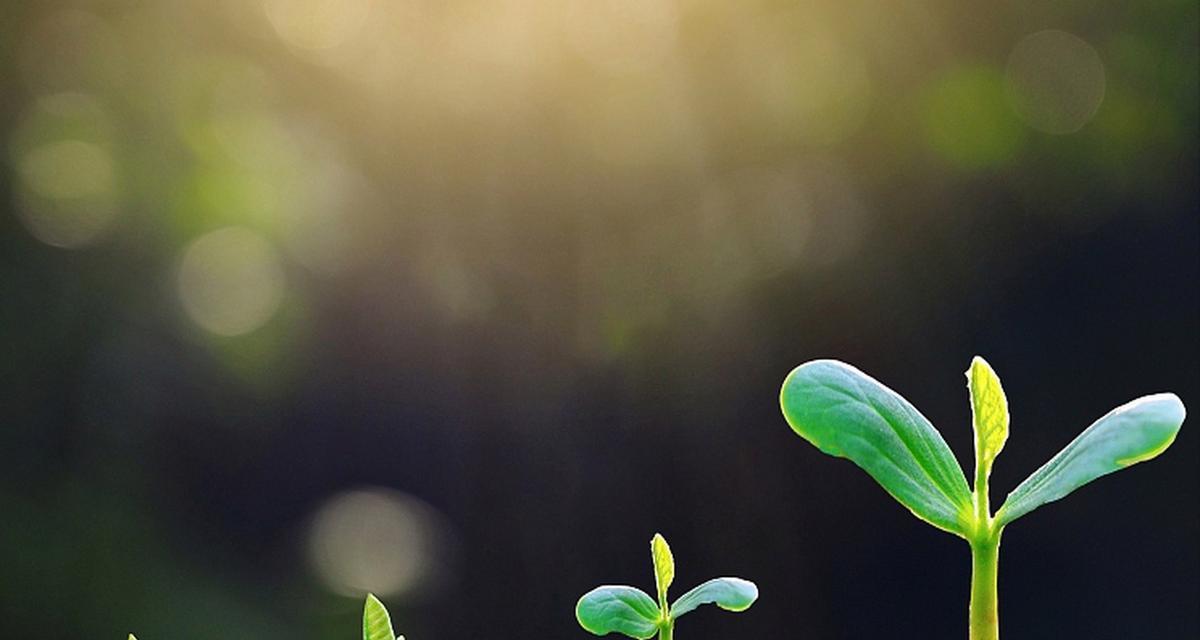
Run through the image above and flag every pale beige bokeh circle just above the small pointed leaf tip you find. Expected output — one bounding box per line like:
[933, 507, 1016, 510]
[308, 489, 444, 597]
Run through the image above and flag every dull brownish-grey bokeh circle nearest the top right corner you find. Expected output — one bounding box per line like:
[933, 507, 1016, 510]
[1004, 30, 1105, 134]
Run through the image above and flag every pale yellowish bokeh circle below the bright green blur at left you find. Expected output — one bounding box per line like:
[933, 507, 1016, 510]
[179, 227, 286, 336]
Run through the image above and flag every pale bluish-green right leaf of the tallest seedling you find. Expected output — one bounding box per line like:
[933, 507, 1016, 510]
[996, 394, 1187, 526]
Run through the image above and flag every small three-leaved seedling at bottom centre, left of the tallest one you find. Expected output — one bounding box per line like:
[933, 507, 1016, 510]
[575, 533, 758, 640]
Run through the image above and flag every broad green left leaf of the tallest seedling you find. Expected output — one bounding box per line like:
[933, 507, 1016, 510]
[780, 360, 972, 536]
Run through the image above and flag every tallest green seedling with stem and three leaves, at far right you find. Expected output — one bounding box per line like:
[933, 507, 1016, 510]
[780, 357, 1184, 640]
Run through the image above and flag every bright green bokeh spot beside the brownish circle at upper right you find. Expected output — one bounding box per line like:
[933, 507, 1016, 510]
[924, 67, 1025, 168]
